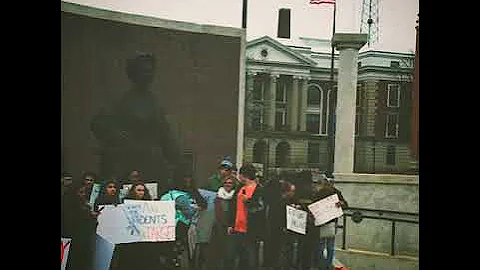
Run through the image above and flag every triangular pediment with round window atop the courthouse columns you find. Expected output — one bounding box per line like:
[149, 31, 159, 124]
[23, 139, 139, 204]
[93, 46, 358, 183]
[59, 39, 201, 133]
[246, 36, 317, 66]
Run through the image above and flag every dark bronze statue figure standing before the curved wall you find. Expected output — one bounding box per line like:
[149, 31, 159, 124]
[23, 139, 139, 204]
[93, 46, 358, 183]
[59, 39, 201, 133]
[91, 53, 181, 185]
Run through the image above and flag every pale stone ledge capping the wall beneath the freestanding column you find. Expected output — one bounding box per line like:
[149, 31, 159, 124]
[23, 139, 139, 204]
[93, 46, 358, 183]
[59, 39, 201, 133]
[333, 173, 419, 186]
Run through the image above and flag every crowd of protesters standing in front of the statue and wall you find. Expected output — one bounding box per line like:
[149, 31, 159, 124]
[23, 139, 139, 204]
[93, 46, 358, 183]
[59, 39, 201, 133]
[62, 158, 347, 270]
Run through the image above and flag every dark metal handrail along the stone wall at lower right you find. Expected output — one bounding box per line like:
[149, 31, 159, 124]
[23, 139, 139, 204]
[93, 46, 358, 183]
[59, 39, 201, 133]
[337, 207, 419, 256]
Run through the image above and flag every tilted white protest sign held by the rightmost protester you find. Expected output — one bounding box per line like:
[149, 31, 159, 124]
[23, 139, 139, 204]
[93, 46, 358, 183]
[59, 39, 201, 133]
[308, 194, 343, 226]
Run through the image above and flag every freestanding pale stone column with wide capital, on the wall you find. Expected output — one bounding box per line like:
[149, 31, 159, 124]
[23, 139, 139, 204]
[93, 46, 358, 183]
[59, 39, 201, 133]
[332, 33, 367, 173]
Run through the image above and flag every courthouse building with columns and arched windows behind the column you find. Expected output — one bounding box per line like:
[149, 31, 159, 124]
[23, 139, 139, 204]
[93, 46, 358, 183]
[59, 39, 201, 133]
[243, 36, 415, 173]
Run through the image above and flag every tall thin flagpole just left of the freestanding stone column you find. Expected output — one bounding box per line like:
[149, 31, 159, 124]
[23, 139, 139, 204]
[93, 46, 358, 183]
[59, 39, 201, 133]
[327, 1, 337, 177]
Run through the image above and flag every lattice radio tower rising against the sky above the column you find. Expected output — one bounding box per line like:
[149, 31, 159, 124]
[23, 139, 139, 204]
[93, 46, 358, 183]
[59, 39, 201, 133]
[360, 0, 379, 47]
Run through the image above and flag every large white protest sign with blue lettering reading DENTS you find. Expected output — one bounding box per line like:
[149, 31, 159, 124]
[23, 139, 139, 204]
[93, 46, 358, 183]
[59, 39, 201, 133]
[97, 200, 175, 244]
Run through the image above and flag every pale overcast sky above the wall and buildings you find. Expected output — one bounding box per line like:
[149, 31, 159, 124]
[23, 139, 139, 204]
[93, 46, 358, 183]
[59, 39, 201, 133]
[65, 0, 419, 52]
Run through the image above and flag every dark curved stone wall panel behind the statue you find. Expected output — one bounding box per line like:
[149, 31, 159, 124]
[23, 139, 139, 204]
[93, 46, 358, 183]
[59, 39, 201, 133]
[61, 11, 241, 183]
